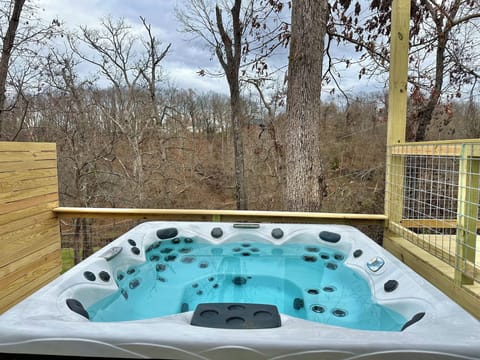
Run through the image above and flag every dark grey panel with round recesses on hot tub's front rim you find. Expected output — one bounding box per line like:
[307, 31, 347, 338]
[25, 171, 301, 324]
[190, 303, 282, 329]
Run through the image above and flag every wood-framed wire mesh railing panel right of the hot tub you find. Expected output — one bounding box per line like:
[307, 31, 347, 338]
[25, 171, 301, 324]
[386, 143, 480, 283]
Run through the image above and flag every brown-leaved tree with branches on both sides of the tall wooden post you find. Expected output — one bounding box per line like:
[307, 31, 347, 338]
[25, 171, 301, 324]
[327, 0, 480, 141]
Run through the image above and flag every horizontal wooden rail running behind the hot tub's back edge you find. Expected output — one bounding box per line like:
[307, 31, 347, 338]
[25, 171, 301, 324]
[53, 207, 387, 225]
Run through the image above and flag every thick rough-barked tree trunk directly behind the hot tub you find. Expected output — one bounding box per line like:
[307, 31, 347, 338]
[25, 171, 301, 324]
[284, 0, 327, 211]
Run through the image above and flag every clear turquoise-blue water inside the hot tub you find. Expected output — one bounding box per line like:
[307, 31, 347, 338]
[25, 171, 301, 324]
[87, 237, 406, 331]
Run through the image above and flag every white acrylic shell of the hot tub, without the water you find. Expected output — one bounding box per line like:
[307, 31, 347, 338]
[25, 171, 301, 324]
[0, 221, 480, 360]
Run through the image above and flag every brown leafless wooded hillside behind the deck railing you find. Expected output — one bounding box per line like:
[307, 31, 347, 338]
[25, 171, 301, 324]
[7, 83, 480, 213]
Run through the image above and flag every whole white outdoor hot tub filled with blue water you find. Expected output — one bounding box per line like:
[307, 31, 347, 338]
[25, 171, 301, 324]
[0, 221, 480, 360]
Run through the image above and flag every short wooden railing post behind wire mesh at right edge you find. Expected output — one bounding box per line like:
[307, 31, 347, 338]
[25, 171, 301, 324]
[455, 144, 480, 286]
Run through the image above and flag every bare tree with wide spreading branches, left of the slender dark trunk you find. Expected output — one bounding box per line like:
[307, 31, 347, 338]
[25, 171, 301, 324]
[70, 18, 170, 206]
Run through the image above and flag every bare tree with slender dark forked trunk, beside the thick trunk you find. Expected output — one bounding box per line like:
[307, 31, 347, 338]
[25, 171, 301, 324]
[177, 0, 284, 209]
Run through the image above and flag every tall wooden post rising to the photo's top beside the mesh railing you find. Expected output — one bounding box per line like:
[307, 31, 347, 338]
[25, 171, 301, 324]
[385, 0, 410, 226]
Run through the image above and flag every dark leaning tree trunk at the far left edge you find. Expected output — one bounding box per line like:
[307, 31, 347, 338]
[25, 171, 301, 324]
[0, 0, 25, 140]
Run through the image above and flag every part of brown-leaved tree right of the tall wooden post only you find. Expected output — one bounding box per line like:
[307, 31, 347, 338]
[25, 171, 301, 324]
[411, 0, 480, 141]
